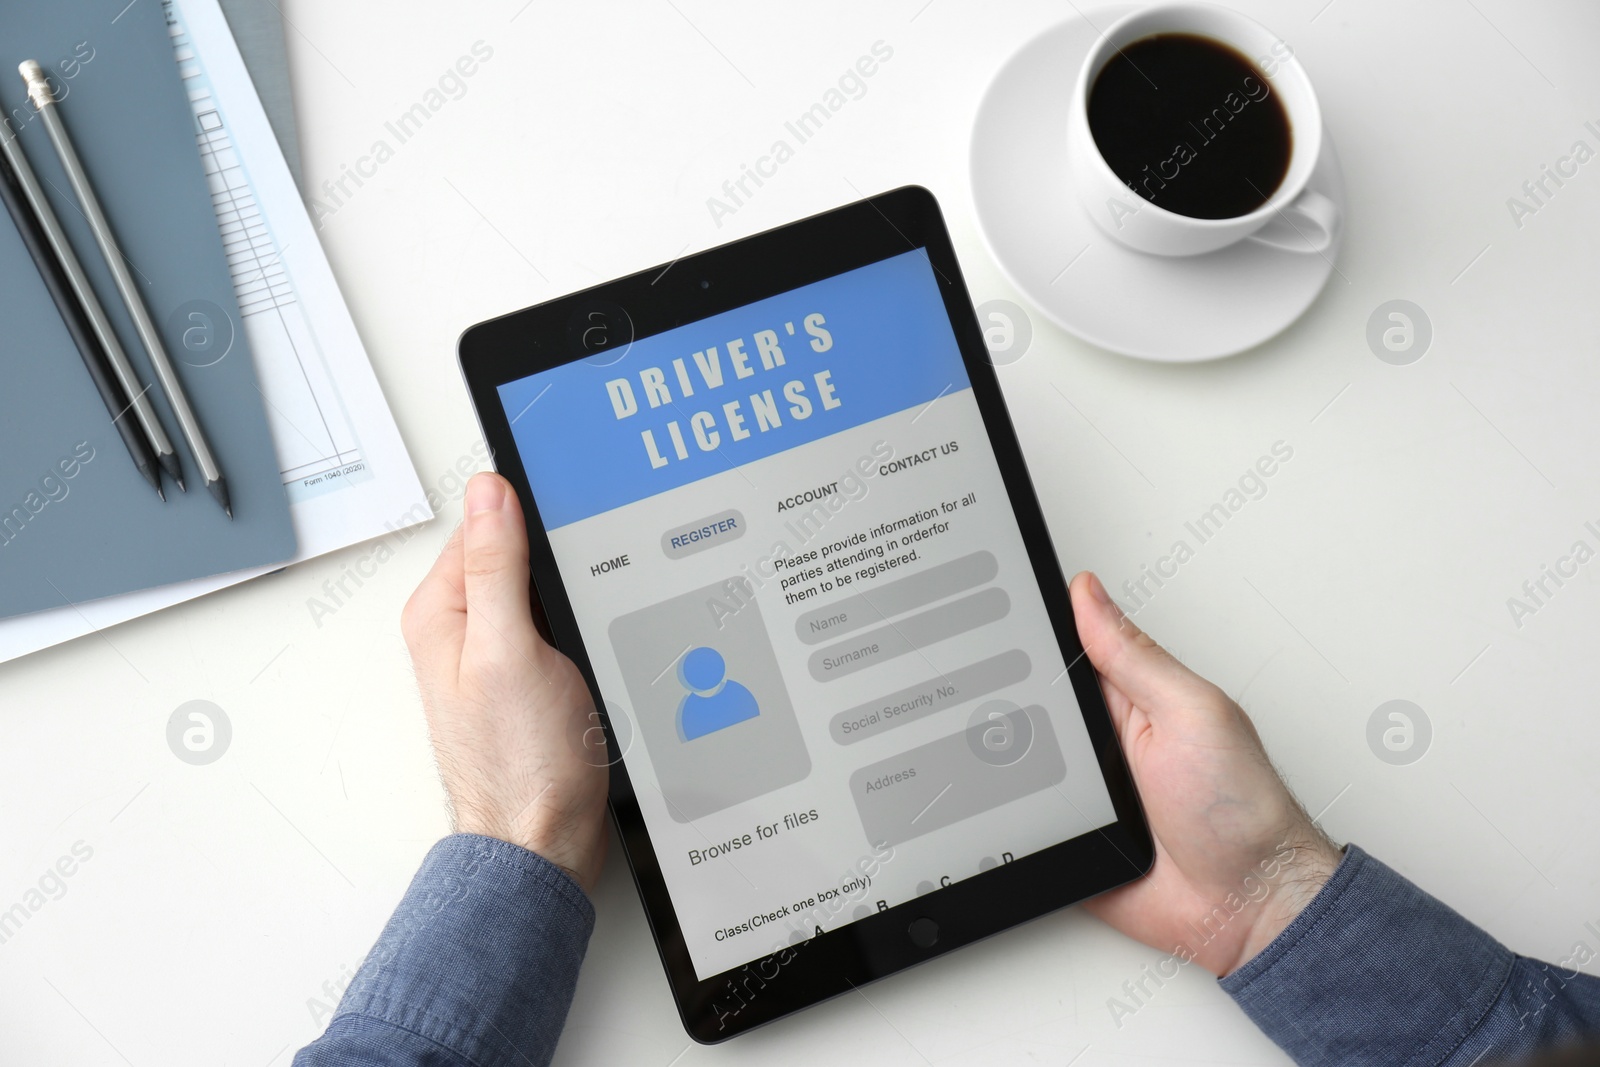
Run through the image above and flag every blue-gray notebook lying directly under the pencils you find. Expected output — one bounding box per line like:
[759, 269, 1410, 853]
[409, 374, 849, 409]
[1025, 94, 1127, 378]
[0, 0, 294, 616]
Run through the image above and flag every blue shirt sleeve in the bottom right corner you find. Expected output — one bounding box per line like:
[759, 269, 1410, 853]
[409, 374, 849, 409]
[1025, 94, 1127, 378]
[1221, 845, 1600, 1067]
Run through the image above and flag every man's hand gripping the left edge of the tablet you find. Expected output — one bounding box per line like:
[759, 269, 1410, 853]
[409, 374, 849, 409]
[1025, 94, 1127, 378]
[402, 474, 608, 891]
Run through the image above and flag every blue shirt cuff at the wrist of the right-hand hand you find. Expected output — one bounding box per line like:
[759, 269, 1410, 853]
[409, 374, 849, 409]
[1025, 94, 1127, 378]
[1221, 845, 1514, 1067]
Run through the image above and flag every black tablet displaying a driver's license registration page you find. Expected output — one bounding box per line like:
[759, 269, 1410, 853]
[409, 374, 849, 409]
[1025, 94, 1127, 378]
[461, 187, 1152, 1043]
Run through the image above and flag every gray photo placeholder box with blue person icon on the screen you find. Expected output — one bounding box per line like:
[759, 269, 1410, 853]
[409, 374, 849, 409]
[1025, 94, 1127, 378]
[610, 577, 811, 822]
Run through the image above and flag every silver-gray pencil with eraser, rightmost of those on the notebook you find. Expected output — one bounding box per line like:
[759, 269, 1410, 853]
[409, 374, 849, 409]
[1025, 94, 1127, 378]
[18, 59, 234, 518]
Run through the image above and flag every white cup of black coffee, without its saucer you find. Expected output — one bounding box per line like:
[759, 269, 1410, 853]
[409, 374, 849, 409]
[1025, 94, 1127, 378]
[1067, 3, 1341, 256]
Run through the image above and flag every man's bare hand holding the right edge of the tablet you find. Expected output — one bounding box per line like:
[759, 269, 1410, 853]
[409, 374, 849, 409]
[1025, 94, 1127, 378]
[1072, 573, 1339, 977]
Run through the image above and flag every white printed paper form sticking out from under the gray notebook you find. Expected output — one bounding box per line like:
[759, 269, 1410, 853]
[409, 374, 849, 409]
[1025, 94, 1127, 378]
[0, 0, 434, 662]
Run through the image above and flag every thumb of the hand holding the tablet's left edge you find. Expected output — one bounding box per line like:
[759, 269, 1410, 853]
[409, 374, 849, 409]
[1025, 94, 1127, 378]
[462, 472, 534, 656]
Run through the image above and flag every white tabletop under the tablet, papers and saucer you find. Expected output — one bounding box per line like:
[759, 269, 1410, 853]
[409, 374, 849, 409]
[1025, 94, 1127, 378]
[0, 0, 1600, 1067]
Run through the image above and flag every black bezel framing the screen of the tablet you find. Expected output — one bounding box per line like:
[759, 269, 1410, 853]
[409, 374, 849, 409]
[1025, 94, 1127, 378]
[459, 186, 1154, 1045]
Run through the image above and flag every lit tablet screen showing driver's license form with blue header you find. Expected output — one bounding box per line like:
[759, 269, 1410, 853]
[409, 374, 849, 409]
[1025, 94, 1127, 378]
[499, 248, 1117, 979]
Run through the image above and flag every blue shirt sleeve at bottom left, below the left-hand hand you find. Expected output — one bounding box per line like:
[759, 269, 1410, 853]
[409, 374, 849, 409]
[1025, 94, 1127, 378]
[294, 833, 594, 1067]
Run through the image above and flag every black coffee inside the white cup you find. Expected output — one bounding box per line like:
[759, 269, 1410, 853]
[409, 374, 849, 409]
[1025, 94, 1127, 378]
[1088, 34, 1294, 219]
